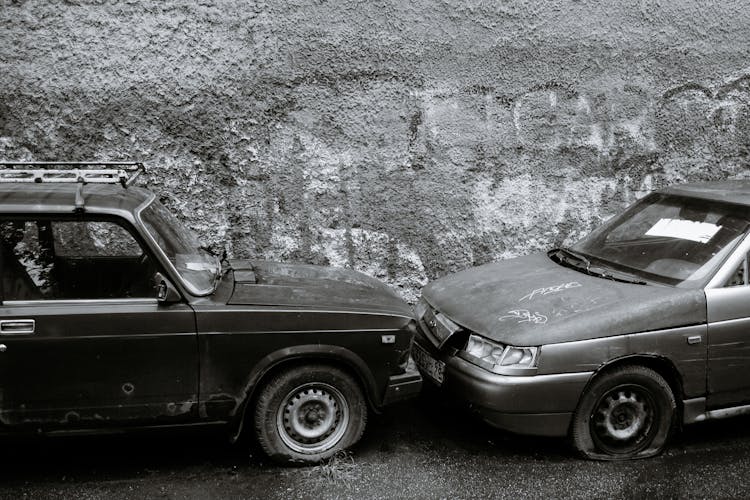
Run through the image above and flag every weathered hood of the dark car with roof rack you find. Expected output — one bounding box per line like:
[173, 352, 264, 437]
[228, 260, 413, 318]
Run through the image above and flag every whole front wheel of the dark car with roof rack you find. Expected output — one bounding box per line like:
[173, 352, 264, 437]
[254, 364, 367, 464]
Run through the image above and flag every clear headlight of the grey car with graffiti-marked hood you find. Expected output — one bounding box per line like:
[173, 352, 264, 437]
[463, 335, 539, 375]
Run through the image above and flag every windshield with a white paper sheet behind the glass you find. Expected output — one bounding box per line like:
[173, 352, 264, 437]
[571, 193, 748, 288]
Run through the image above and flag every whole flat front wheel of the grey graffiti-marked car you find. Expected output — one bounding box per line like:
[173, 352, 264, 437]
[571, 365, 676, 460]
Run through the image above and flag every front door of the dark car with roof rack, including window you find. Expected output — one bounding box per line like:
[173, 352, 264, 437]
[0, 216, 198, 427]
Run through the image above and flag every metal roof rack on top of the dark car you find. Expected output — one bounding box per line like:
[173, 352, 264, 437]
[0, 161, 146, 187]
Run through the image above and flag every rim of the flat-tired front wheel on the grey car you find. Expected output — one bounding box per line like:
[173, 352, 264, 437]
[589, 384, 659, 455]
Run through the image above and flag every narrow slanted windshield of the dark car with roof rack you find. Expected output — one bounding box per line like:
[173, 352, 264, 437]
[140, 200, 221, 295]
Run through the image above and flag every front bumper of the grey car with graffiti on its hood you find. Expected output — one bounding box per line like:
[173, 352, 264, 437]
[419, 342, 592, 436]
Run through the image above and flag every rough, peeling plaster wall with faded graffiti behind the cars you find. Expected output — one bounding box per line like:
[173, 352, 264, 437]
[0, 0, 750, 300]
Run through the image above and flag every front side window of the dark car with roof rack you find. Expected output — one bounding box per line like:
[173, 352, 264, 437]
[0, 219, 156, 300]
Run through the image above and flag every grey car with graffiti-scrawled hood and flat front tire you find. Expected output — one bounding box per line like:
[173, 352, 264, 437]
[413, 181, 750, 459]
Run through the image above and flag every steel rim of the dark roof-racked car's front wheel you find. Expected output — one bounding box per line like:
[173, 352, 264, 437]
[276, 382, 349, 454]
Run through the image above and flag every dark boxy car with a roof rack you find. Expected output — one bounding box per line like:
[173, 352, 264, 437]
[0, 163, 421, 462]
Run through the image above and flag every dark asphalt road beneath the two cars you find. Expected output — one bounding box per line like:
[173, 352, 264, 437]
[0, 393, 750, 499]
